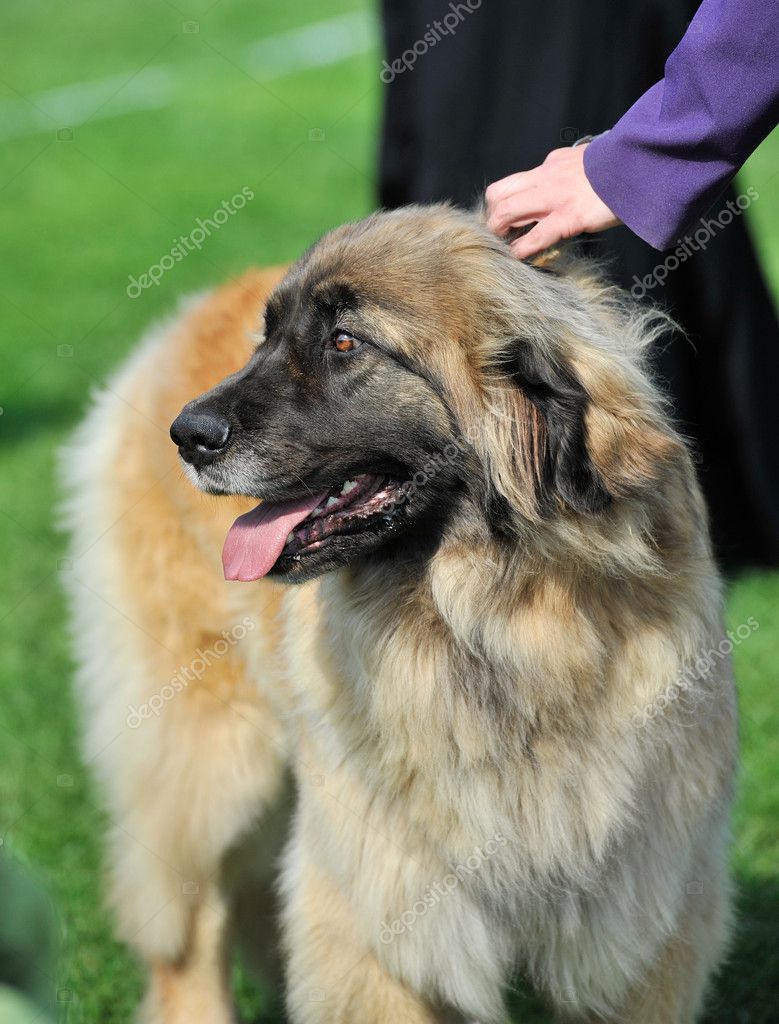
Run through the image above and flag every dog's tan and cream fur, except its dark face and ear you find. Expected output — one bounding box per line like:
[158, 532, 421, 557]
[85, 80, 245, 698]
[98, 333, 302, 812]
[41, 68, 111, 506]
[67, 208, 735, 1024]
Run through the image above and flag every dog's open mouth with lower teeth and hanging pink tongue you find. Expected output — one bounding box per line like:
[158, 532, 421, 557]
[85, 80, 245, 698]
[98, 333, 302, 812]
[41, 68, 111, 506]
[222, 473, 405, 581]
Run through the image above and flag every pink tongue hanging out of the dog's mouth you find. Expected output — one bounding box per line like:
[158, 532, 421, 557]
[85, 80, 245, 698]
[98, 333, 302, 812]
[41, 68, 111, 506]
[222, 490, 327, 582]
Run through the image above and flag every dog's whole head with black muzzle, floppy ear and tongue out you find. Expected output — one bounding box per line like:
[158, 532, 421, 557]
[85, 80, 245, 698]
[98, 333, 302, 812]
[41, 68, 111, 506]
[171, 206, 679, 582]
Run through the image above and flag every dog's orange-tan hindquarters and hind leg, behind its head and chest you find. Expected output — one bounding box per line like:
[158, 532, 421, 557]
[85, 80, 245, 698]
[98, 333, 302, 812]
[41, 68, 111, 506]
[64, 280, 284, 1024]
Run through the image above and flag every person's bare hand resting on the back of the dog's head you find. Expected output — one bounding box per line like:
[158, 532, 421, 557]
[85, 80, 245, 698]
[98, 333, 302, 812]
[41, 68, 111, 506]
[485, 145, 621, 259]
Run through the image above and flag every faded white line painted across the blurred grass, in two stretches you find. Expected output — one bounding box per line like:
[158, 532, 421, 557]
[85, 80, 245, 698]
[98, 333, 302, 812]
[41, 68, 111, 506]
[0, 11, 376, 139]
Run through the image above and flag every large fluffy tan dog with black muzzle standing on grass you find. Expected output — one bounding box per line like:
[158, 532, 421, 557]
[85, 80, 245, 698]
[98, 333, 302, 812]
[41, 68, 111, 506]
[62, 207, 736, 1024]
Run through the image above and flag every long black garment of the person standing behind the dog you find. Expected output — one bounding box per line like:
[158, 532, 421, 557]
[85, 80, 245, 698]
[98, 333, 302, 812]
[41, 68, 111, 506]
[380, 0, 779, 566]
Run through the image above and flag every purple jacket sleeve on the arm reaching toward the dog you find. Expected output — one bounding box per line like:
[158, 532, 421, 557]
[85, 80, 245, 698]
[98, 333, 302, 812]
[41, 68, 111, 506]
[585, 0, 779, 249]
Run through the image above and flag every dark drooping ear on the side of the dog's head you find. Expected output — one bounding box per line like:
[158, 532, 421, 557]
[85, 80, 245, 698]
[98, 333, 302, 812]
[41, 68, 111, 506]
[491, 338, 611, 515]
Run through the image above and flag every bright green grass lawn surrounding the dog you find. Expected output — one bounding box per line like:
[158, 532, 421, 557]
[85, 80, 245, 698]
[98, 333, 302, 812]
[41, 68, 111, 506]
[0, 0, 779, 1024]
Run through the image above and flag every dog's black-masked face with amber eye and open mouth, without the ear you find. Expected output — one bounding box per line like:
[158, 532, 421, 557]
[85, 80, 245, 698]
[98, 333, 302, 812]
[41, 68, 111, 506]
[172, 208, 474, 582]
